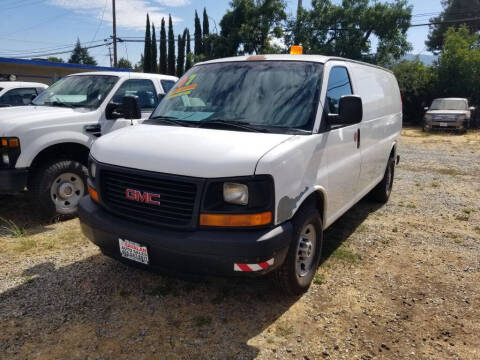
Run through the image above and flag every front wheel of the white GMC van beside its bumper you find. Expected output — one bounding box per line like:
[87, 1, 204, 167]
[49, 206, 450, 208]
[274, 205, 323, 296]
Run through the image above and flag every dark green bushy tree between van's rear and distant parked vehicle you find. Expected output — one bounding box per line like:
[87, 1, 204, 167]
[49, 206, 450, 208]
[392, 58, 435, 122]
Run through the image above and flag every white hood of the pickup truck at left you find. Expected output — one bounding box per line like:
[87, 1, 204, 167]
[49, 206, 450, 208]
[0, 105, 90, 136]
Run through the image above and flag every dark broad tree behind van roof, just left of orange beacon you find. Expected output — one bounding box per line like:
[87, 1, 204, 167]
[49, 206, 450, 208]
[219, 0, 286, 55]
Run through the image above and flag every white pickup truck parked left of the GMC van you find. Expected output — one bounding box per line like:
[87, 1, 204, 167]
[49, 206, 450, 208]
[0, 72, 177, 217]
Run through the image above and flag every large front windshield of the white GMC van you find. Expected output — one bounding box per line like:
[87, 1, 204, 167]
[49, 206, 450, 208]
[148, 61, 323, 132]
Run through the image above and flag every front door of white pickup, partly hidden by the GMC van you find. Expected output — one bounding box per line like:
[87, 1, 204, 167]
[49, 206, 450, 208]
[101, 79, 159, 135]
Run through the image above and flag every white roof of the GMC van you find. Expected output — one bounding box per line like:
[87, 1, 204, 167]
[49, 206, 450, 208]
[195, 54, 392, 73]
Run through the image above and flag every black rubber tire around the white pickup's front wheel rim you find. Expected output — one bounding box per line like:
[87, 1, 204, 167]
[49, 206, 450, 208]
[29, 160, 88, 220]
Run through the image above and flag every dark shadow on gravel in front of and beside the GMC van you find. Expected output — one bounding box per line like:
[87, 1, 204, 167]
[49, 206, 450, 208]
[0, 197, 379, 359]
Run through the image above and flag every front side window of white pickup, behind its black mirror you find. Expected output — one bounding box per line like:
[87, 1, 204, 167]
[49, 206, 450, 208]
[112, 79, 158, 110]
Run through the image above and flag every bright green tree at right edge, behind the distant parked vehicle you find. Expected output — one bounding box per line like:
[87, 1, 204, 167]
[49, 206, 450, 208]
[436, 25, 480, 105]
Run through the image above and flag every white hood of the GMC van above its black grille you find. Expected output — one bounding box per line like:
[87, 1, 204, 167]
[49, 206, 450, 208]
[91, 125, 294, 178]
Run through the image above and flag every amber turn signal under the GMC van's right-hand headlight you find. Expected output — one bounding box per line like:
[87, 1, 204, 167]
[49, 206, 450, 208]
[200, 211, 272, 227]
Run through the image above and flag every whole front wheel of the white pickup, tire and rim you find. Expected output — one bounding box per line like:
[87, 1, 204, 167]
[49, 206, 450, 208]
[30, 160, 88, 219]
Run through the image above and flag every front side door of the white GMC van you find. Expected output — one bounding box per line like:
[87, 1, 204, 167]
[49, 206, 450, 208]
[323, 62, 361, 222]
